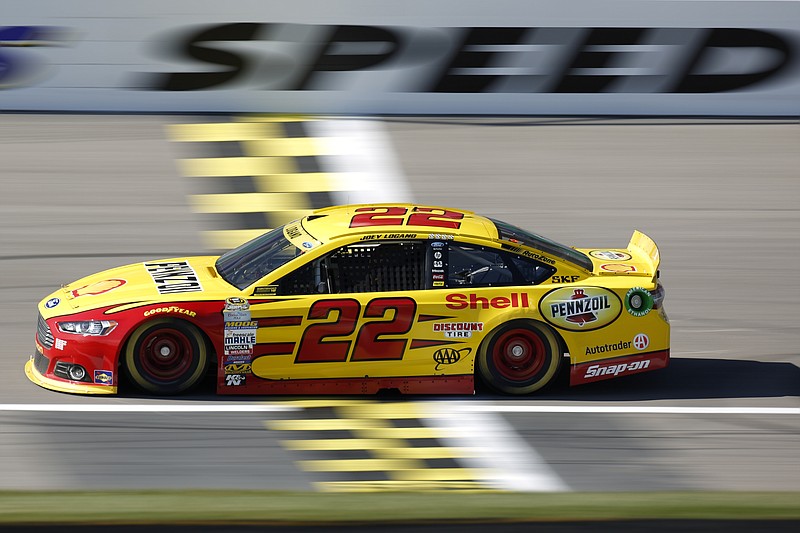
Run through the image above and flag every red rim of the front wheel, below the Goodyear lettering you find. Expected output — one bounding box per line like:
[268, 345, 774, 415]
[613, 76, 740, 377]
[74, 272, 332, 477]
[139, 328, 195, 381]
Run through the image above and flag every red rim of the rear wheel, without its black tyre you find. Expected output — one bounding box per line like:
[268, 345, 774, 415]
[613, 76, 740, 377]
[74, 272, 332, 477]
[492, 329, 547, 381]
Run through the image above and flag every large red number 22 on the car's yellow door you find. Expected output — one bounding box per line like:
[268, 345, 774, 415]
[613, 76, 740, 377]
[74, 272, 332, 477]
[294, 297, 417, 363]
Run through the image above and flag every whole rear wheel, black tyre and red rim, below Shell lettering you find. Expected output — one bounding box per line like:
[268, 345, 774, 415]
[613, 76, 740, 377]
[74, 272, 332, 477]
[478, 320, 561, 394]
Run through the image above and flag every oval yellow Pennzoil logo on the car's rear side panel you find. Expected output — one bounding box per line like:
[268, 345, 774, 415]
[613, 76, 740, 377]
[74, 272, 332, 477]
[539, 287, 622, 331]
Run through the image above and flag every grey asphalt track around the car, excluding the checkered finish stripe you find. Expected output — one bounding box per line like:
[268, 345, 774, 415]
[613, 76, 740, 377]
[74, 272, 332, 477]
[0, 115, 800, 508]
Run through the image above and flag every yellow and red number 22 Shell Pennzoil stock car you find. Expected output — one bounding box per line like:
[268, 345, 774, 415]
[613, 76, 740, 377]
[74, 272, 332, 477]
[25, 204, 669, 394]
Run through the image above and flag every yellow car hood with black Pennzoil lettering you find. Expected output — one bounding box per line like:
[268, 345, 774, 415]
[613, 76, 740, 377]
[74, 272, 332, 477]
[39, 256, 231, 317]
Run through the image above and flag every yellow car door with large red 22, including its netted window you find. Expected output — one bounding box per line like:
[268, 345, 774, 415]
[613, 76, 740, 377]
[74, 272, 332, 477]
[251, 240, 441, 379]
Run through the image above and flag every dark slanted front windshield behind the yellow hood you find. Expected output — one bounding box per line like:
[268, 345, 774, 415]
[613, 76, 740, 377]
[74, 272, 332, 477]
[215, 227, 303, 290]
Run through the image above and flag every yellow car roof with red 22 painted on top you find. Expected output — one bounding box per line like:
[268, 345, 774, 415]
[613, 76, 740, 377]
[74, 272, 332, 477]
[300, 203, 498, 242]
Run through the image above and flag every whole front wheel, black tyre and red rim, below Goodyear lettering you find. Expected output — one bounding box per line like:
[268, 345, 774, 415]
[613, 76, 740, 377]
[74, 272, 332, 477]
[125, 318, 208, 394]
